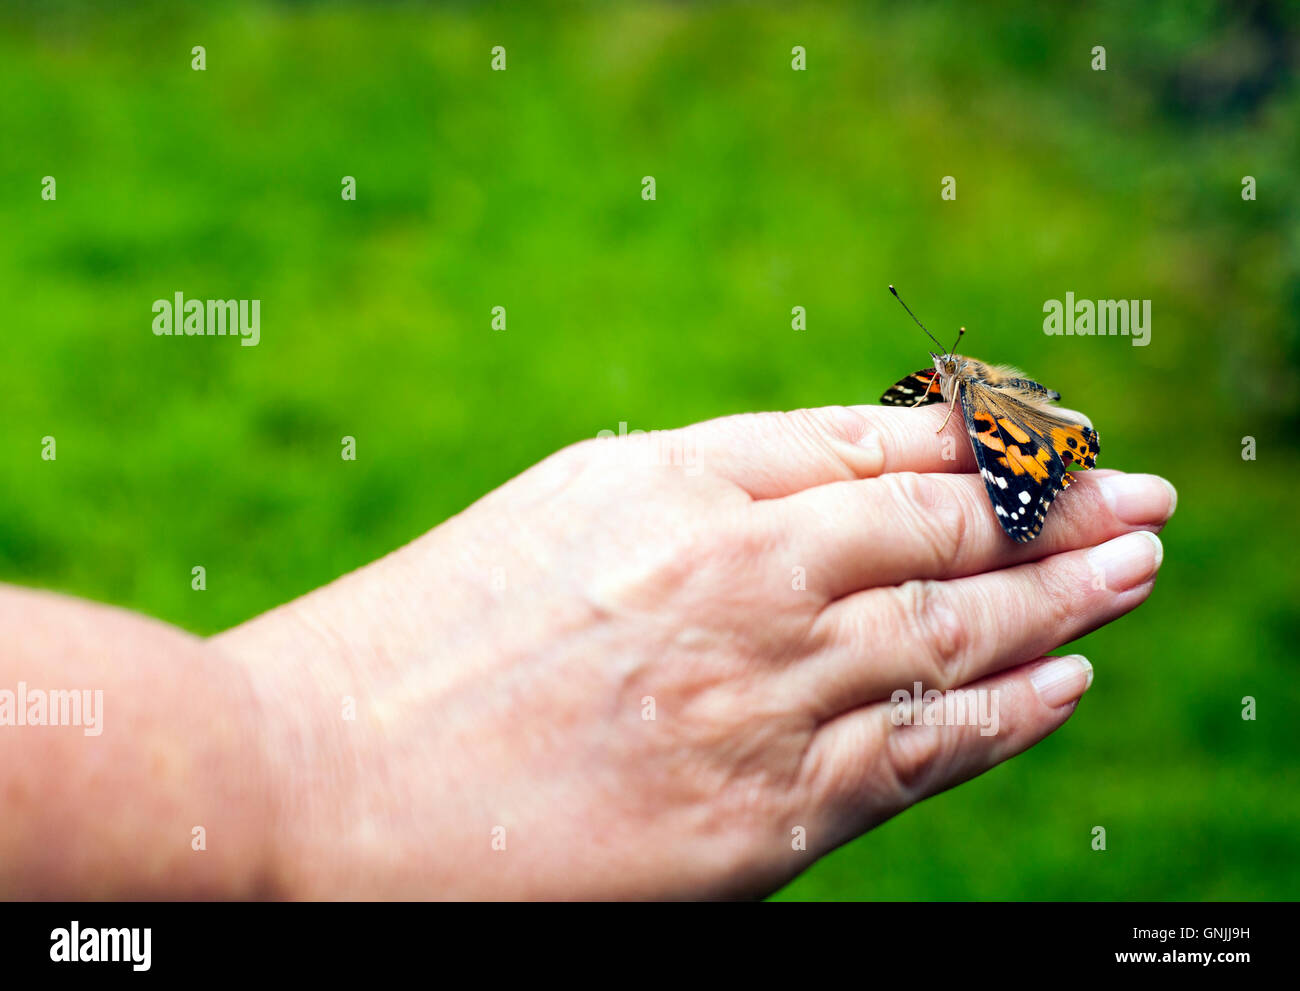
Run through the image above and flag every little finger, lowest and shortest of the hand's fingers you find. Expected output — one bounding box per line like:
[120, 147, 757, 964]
[803, 655, 1092, 847]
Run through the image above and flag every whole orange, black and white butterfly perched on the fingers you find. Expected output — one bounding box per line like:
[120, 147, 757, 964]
[880, 286, 1101, 544]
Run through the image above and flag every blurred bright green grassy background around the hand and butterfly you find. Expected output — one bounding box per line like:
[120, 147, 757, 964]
[0, 1, 1300, 900]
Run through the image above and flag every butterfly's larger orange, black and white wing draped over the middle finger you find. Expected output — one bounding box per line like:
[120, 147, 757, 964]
[961, 381, 1101, 544]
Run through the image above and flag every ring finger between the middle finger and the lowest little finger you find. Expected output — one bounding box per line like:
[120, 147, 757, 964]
[781, 531, 1164, 718]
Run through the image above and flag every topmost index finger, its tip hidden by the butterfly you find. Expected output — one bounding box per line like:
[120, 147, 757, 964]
[673, 406, 975, 499]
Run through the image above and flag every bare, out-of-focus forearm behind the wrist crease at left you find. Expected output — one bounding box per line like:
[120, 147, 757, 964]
[0, 587, 278, 899]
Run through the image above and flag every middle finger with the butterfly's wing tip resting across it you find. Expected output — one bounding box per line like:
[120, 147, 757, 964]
[762, 469, 1178, 598]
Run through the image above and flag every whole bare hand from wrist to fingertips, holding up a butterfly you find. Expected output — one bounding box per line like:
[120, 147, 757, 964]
[215, 406, 1175, 899]
